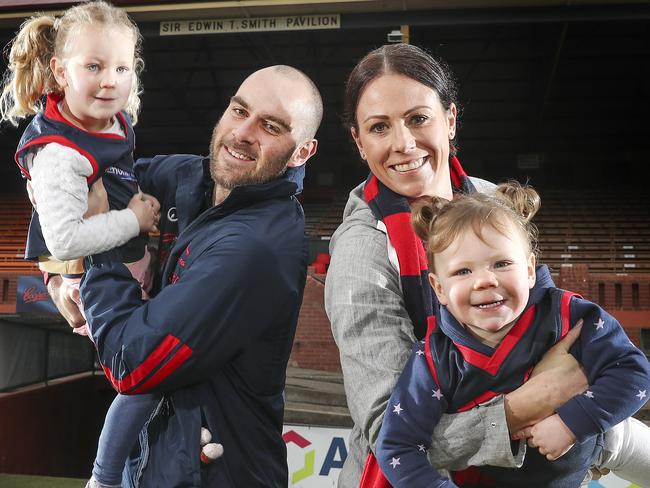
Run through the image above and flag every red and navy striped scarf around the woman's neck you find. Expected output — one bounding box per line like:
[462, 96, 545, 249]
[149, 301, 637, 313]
[364, 156, 476, 340]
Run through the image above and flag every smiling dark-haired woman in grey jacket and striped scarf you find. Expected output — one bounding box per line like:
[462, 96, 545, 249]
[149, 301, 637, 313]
[325, 44, 647, 488]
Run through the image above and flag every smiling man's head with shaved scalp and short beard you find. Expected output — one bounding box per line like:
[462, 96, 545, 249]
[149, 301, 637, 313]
[210, 65, 323, 203]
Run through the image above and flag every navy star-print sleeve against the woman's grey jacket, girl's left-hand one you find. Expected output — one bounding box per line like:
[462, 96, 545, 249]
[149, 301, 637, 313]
[375, 342, 456, 488]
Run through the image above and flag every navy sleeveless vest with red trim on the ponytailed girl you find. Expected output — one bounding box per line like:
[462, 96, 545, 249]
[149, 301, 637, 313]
[15, 94, 145, 262]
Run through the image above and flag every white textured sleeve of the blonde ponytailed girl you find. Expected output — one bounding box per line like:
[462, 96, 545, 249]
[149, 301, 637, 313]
[30, 143, 140, 261]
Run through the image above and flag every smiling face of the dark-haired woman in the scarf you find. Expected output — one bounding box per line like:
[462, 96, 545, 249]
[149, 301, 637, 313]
[352, 73, 456, 199]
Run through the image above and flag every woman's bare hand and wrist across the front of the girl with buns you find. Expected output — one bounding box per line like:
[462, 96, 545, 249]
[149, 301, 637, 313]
[505, 320, 589, 432]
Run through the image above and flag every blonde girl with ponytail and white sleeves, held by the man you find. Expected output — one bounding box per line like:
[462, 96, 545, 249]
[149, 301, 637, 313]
[0, 1, 220, 486]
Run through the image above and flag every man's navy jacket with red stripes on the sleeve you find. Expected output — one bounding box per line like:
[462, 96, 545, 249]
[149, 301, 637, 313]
[81, 155, 307, 488]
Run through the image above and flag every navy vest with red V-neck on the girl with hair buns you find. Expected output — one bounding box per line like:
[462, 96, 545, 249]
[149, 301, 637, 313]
[425, 288, 602, 488]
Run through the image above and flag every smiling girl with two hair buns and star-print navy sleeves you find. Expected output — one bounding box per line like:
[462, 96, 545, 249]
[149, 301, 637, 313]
[376, 184, 650, 488]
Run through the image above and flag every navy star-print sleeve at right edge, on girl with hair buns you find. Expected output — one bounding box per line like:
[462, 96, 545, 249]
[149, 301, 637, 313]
[557, 298, 650, 441]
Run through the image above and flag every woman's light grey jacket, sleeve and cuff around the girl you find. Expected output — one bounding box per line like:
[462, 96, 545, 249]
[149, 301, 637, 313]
[325, 178, 525, 488]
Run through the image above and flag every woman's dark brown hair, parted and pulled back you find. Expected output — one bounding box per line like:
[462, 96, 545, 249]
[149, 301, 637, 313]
[344, 44, 458, 154]
